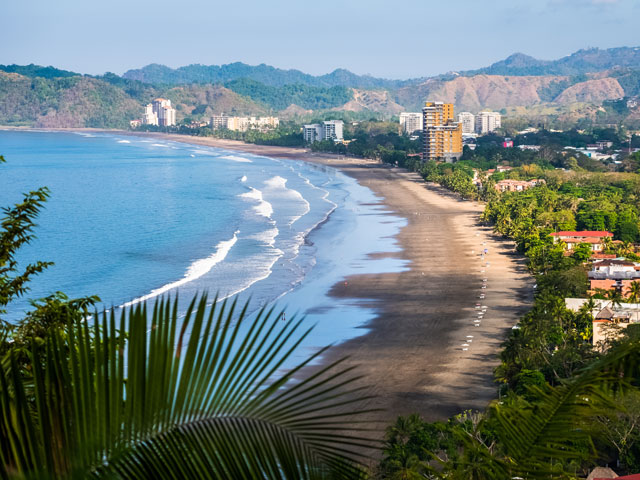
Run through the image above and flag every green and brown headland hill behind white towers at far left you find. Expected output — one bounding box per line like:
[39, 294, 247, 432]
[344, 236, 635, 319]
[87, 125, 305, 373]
[0, 71, 267, 128]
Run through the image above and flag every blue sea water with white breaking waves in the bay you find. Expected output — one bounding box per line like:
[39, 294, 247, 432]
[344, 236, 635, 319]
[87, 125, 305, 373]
[0, 131, 406, 356]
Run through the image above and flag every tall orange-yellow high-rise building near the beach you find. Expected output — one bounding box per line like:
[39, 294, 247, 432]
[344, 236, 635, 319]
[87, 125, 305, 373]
[422, 102, 462, 162]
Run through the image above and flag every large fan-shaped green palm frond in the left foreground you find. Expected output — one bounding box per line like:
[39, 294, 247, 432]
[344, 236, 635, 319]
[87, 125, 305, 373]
[0, 295, 375, 479]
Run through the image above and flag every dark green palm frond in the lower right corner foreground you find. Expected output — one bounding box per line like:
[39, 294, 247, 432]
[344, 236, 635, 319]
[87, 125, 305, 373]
[490, 342, 640, 478]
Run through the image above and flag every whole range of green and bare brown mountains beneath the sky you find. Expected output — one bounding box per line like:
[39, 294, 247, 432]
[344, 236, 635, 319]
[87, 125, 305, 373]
[0, 47, 640, 128]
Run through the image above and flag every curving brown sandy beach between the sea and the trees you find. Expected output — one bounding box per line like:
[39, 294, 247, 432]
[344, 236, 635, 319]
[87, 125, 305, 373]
[0, 127, 534, 424]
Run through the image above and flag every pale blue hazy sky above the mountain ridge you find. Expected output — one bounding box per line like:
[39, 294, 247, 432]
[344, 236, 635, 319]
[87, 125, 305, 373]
[0, 0, 640, 78]
